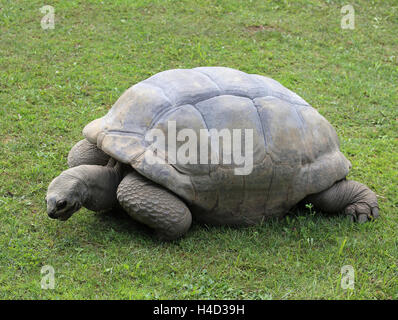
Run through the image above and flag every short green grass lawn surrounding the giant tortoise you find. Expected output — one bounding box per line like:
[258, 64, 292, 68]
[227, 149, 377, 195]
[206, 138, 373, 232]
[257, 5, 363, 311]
[0, 0, 398, 299]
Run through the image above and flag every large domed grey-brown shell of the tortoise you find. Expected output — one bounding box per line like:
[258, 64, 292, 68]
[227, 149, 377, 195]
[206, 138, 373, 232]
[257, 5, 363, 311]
[83, 67, 351, 225]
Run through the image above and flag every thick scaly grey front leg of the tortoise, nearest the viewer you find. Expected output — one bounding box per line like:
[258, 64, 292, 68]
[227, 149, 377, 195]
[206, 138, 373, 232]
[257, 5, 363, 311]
[117, 172, 192, 240]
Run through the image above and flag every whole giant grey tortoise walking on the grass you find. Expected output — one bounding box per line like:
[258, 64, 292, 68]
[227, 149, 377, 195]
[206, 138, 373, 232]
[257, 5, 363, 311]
[47, 67, 379, 240]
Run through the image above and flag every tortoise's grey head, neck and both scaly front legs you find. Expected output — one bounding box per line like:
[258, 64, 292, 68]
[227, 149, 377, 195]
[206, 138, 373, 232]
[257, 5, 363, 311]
[46, 140, 192, 240]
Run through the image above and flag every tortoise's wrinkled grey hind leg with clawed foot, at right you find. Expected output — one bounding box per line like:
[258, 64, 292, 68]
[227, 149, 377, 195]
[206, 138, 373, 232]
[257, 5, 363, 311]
[304, 179, 379, 222]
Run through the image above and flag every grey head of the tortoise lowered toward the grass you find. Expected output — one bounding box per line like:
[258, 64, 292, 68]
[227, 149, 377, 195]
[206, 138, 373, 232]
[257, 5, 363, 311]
[46, 172, 85, 221]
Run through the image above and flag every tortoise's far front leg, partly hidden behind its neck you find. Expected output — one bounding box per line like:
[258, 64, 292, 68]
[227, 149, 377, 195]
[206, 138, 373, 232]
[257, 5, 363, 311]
[68, 139, 110, 168]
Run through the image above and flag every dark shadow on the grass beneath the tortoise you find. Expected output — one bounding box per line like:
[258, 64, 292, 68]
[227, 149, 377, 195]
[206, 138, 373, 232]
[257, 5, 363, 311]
[81, 204, 353, 246]
